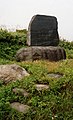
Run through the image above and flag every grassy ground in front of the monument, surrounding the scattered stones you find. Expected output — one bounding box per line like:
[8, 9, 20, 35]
[0, 59, 73, 120]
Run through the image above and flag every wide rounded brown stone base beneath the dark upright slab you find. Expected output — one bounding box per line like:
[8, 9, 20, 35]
[16, 46, 66, 61]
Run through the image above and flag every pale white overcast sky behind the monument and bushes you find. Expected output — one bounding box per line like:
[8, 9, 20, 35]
[0, 0, 73, 41]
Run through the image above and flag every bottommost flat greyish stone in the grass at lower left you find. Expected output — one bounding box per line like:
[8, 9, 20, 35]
[10, 102, 30, 113]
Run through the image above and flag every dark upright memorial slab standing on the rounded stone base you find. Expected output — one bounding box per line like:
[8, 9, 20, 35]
[27, 15, 59, 46]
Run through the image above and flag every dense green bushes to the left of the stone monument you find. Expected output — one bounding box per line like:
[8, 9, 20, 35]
[0, 29, 26, 60]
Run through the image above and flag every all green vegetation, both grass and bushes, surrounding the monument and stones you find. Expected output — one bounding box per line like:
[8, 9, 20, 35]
[0, 30, 73, 120]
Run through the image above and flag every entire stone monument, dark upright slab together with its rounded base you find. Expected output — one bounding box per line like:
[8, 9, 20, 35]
[16, 15, 66, 61]
